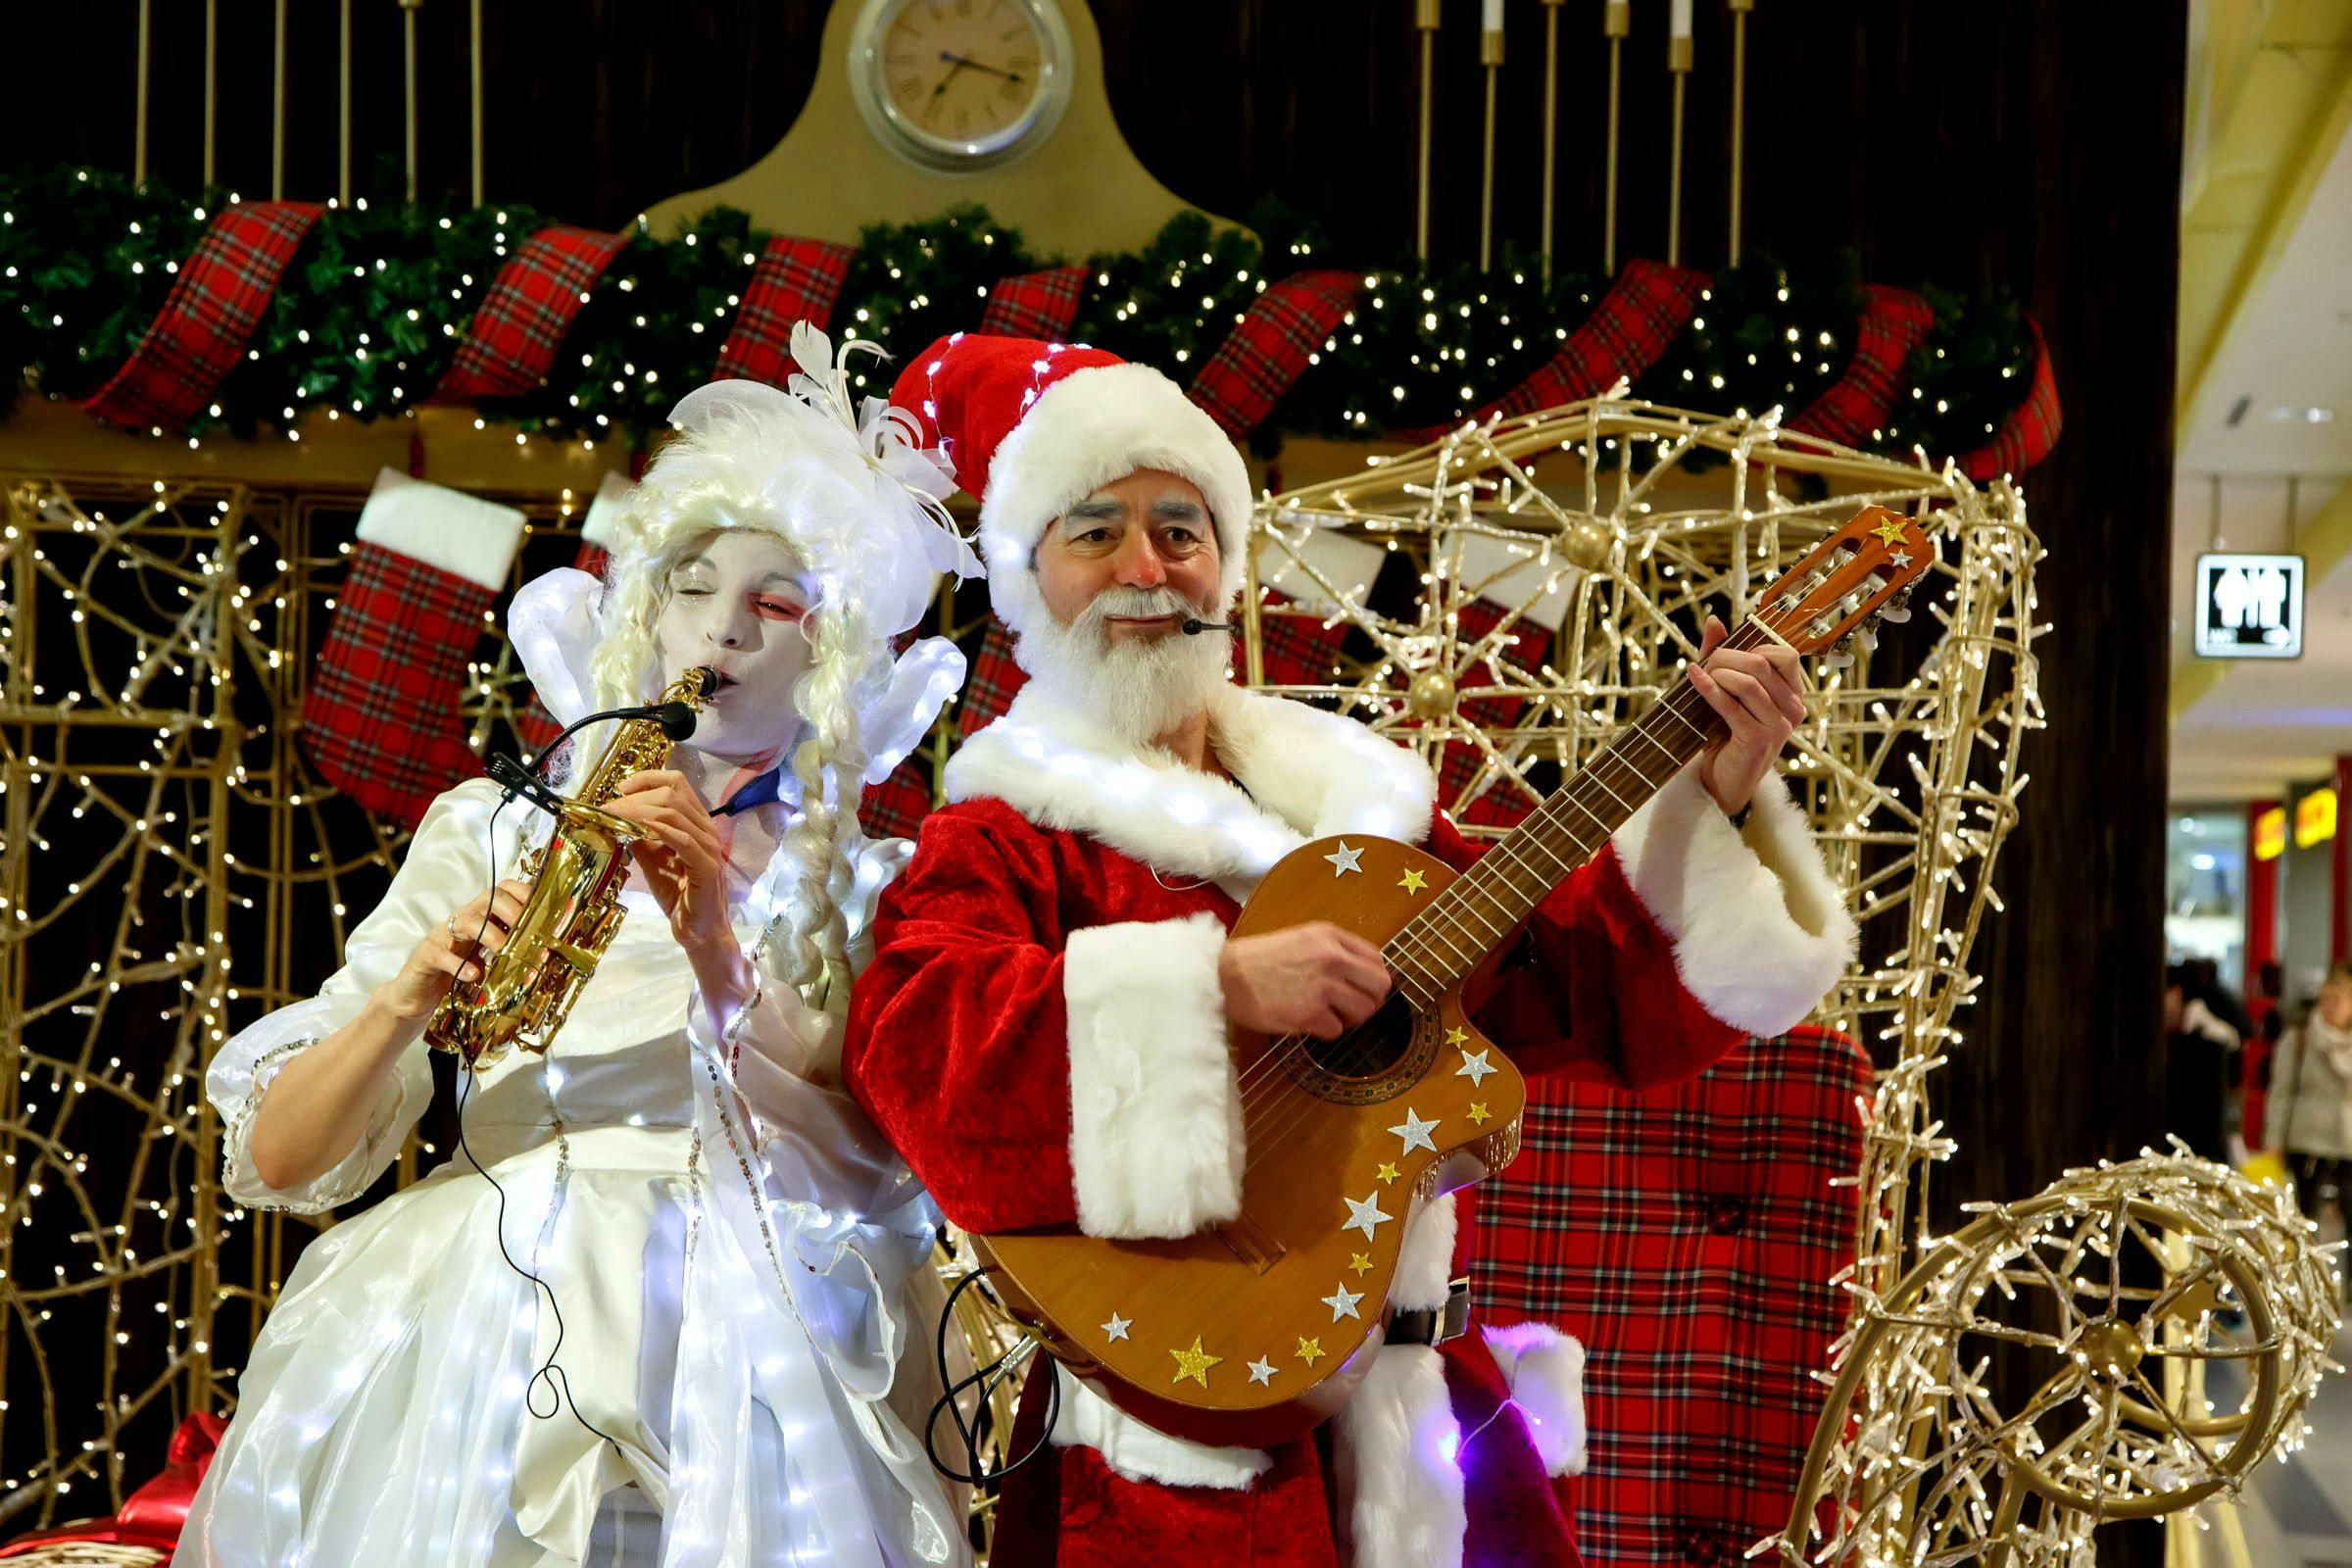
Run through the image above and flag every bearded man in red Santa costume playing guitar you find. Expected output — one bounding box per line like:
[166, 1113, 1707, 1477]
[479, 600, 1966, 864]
[845, 334, 1853, 1568]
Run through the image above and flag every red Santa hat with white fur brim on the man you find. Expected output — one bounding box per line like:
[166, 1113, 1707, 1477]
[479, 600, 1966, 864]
[892, 331, 1249, 632]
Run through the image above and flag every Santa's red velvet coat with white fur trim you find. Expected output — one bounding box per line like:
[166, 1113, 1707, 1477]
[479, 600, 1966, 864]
[845, 684, 1853, 1568]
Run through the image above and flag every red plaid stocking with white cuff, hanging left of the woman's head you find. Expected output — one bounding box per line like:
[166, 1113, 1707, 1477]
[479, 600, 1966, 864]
[304, 470, 522, 827]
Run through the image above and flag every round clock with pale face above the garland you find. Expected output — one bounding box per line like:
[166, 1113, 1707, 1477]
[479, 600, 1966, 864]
[849, 0, 1070, 170]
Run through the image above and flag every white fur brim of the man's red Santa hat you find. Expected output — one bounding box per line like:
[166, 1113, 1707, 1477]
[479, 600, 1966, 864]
[981, 365, 1251, 632]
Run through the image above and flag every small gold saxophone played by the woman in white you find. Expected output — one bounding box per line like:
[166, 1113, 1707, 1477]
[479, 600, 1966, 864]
[425, 667, 712, 1072]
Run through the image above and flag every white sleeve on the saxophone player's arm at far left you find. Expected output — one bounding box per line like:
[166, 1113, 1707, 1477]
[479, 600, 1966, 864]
[205, 778, 519, 1213]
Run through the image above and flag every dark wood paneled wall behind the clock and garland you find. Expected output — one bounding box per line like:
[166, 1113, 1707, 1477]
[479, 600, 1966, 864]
[18, 0, 2187, 1551]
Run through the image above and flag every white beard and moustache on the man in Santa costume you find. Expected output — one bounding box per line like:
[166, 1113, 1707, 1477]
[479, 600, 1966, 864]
[1013, 590, 1233, 745]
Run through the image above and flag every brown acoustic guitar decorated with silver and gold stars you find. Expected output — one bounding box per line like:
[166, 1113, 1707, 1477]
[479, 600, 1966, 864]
[974, 506, 1934, 1448]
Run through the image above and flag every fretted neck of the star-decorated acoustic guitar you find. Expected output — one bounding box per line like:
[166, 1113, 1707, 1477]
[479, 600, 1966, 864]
[1383, 620, 1771, 1006]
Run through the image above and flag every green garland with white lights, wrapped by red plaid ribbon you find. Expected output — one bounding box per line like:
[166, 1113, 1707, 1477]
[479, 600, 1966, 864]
[0, 170, 2034, 465]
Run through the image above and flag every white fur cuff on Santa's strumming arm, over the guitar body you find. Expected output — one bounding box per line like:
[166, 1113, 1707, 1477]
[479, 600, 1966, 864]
[1060, 914, 1242, 1239]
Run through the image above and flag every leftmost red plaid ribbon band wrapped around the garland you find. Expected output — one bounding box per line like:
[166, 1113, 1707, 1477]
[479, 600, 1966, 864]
[82, 202, 319, 430]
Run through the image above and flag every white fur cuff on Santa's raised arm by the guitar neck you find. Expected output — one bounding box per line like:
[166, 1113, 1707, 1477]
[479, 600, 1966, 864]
[1613, 764, 1853, 1037]
